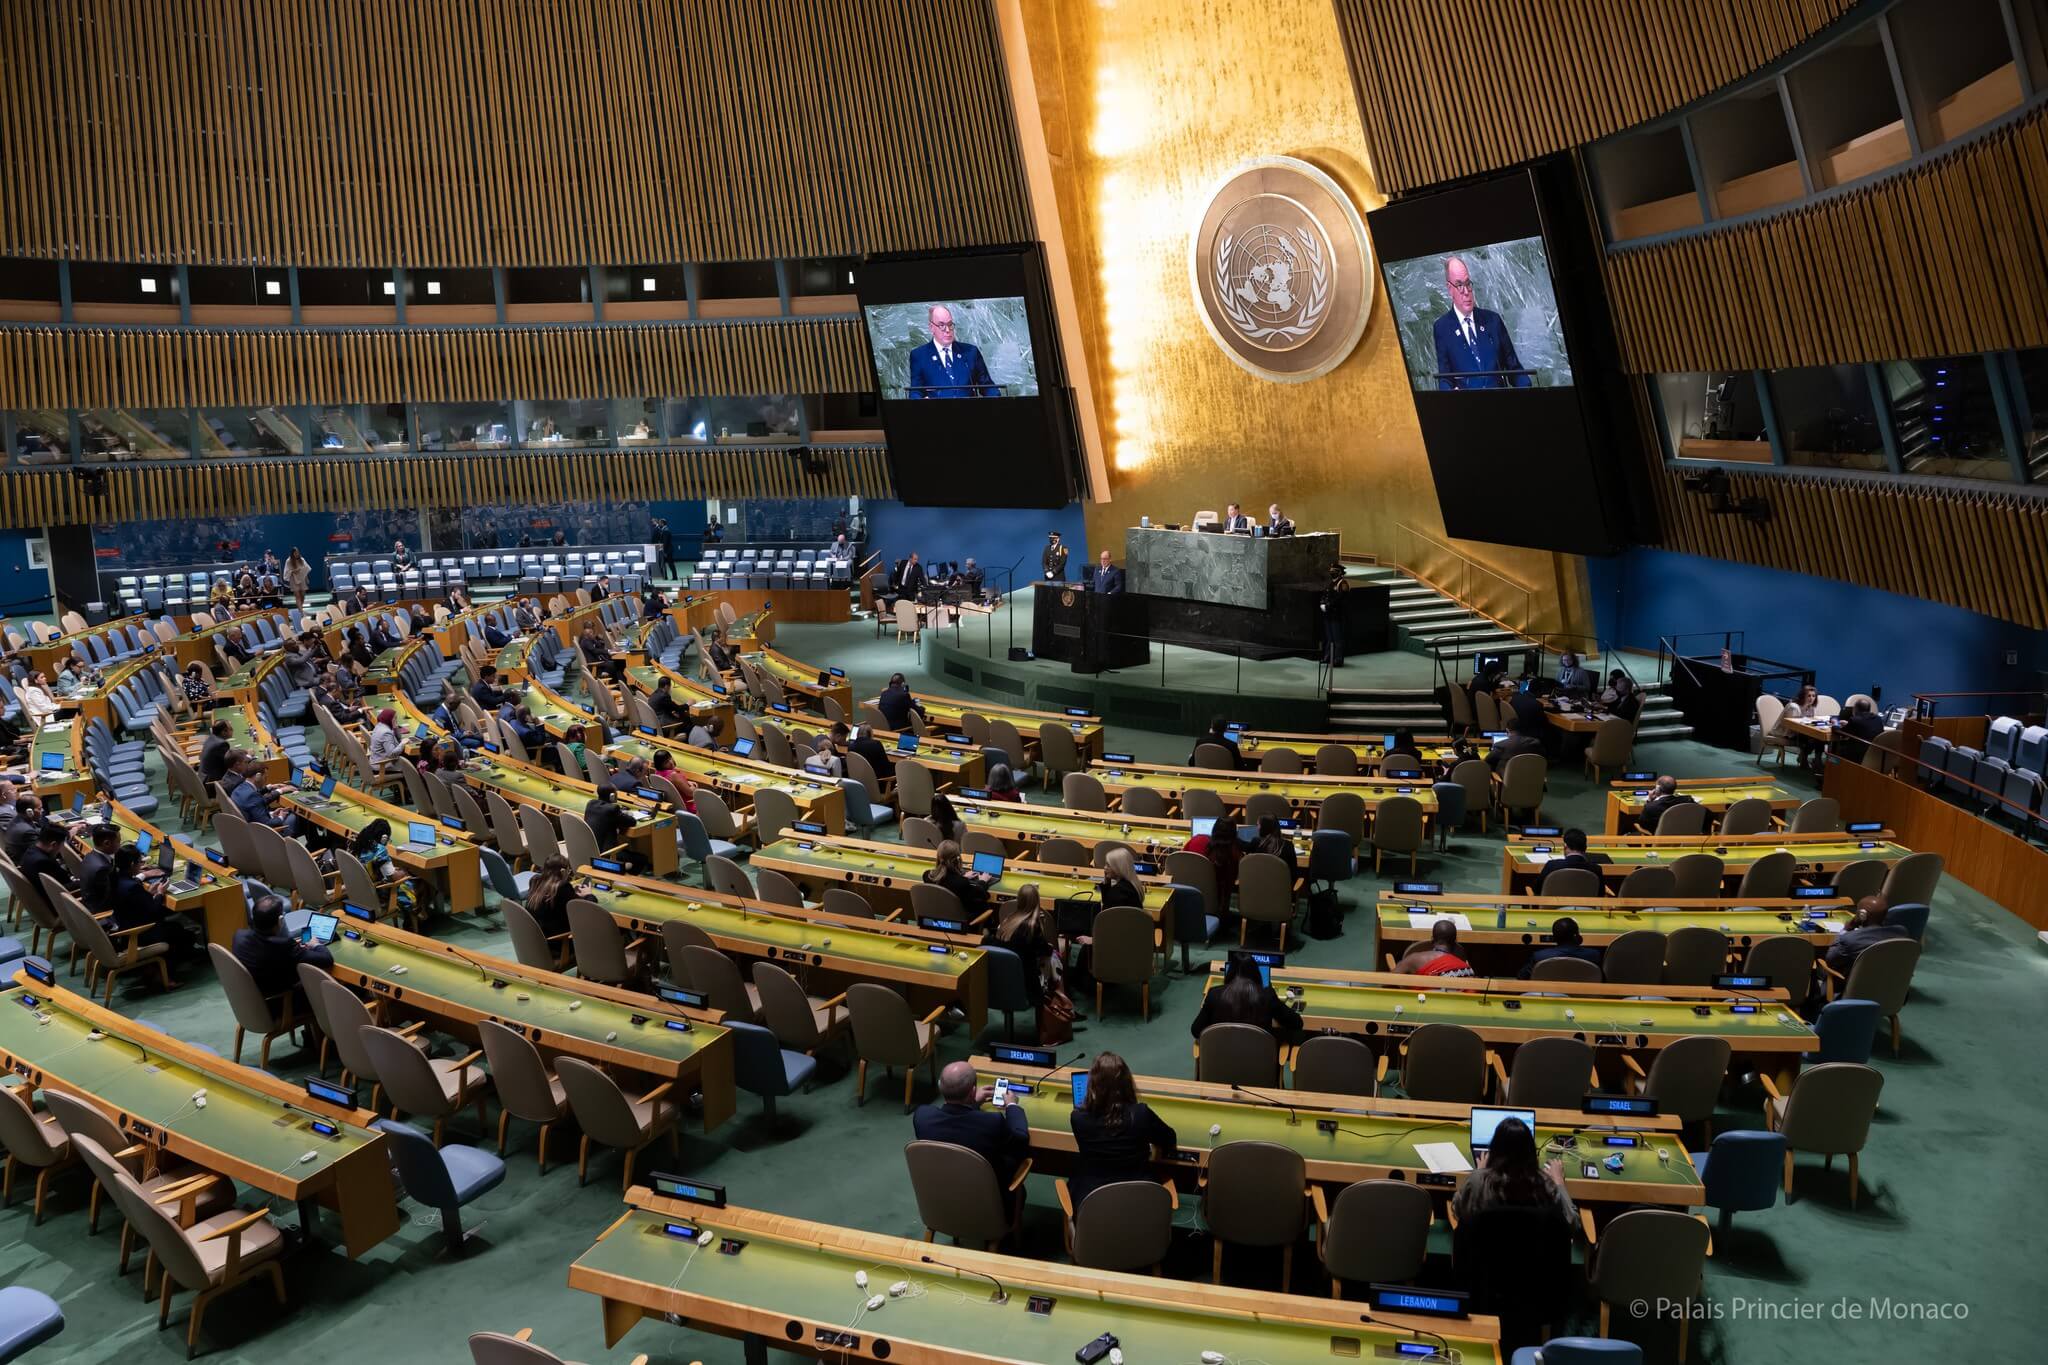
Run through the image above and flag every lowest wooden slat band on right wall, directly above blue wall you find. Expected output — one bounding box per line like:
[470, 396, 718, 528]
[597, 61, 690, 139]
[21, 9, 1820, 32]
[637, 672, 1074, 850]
[1653, 469, 2048, 630]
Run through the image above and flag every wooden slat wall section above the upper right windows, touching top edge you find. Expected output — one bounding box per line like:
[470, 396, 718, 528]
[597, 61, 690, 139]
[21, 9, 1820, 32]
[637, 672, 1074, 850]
[1335, 0, 1858, 194]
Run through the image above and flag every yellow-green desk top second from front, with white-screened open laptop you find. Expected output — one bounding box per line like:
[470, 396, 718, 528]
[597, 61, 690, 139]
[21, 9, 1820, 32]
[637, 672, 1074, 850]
[973, 1056, 1704, 1207]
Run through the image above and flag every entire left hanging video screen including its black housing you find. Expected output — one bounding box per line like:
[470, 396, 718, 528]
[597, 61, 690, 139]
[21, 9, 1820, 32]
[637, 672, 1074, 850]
[858, 244, 1077, 508]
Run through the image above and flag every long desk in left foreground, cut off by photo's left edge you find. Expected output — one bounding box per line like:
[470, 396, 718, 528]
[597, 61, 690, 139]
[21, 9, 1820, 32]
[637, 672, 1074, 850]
[0, 972, 397, 1257]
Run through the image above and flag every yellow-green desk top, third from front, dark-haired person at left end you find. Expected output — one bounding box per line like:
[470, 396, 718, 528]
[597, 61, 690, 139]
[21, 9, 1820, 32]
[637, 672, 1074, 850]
[1206, 962, 1821, 1056]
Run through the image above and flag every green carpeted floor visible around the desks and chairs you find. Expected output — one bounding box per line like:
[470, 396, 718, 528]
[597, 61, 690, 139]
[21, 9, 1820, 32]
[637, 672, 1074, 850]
[0, 622, 2048, 1365]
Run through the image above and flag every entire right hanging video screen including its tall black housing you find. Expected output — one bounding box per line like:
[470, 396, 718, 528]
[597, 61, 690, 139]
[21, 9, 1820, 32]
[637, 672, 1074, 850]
[1366, 158, 1640, 555]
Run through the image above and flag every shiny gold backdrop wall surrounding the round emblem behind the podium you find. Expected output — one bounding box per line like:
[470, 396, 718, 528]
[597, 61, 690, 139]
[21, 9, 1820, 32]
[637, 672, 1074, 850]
[1026, 0, 1591, 630]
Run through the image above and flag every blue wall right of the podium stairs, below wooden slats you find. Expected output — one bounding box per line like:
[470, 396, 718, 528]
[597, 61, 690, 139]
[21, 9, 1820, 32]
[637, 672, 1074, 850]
[1587, 548, 2048, 710]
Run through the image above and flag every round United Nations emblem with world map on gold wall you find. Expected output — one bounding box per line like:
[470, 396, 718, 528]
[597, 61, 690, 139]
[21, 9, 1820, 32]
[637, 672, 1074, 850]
[1188, 156, 1372, 383]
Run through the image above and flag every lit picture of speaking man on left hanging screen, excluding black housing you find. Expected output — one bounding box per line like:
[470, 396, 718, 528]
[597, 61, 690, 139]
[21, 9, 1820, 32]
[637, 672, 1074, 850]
[862, 299, 1038, 399]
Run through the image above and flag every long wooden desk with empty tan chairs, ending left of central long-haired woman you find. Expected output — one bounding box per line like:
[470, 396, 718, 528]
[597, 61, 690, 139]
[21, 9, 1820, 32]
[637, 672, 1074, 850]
[578, 868, 989, 1038]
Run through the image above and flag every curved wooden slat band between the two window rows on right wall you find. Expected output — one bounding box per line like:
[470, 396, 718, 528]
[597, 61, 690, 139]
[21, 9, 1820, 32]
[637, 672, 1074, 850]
[1606, 108, 2048, 375]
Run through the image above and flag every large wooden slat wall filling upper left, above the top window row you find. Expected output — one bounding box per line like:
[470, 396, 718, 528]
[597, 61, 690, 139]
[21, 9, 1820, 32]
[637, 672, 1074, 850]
[0, 0, 1032, 266]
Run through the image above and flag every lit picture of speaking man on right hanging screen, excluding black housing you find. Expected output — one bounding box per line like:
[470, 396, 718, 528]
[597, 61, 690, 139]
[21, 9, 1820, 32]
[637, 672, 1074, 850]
[1380, 237, 1571, 393]
